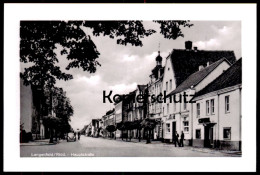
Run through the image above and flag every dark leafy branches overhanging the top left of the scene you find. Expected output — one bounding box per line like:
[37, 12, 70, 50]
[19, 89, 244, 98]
[20, 21, 192, 87]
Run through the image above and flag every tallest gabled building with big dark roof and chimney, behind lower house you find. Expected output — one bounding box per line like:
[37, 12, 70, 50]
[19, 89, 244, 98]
[162, 41, 236, 144]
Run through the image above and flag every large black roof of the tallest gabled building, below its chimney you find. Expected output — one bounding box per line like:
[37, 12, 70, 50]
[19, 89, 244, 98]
[170, 49, 236, 86]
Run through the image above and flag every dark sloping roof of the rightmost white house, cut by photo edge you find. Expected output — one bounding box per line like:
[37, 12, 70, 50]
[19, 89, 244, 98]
[195, 58, 242, 97]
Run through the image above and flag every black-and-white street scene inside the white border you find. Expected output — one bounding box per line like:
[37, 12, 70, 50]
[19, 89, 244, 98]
[17, 20, 243, 158]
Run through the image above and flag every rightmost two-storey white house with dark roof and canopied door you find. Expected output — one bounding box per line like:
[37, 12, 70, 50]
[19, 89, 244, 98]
[193, 59, 242, 150]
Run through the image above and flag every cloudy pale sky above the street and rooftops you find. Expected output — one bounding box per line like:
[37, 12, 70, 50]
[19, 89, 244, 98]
[21, 21, 241, 130]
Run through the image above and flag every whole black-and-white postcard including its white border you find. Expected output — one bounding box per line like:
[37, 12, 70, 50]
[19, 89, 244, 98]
[4, 4, 256, 171]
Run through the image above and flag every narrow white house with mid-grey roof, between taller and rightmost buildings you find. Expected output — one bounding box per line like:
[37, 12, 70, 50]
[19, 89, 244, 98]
[164, 58, 230, 145]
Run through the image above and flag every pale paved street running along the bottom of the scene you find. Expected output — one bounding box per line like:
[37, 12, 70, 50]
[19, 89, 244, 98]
[20, 136, 241, 157]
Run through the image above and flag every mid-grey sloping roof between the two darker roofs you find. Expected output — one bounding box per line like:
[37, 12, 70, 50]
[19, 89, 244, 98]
[169, 58, 230, 95]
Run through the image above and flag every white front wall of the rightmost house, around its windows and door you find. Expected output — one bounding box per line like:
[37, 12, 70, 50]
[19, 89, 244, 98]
[193, 88, 241, 150]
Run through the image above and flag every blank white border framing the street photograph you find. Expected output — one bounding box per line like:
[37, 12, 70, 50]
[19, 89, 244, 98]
[4, 4, 256, 172]
